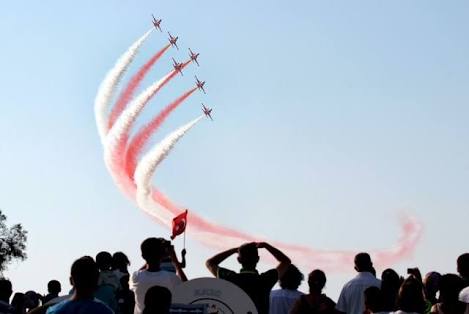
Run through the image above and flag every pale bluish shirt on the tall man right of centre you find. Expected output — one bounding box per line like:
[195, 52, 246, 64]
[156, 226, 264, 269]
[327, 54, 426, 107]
[335, 272, 381, 314]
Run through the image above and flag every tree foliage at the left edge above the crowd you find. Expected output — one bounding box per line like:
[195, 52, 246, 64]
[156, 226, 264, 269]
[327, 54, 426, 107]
[0, 210, 28, 273]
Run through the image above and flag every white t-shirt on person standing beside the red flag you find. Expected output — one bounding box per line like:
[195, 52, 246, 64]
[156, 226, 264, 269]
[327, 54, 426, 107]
[129, 270, 182, 314]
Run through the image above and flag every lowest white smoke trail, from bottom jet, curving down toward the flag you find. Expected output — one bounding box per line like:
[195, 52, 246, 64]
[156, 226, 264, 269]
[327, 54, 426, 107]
[134, 115, 204, 226]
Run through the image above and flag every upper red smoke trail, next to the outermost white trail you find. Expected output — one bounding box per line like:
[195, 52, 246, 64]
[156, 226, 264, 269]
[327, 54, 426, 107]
[108, 44, 171, 129]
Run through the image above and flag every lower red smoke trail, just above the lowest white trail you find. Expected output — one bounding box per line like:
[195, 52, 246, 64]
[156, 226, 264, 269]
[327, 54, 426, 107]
[125, 87, 197, 178]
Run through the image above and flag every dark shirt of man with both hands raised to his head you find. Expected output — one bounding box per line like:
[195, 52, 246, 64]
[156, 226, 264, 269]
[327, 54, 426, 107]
[217, 267, 278, 314]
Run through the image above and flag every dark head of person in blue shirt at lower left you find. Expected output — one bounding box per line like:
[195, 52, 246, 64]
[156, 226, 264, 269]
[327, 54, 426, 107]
[70, 256, 99, 294]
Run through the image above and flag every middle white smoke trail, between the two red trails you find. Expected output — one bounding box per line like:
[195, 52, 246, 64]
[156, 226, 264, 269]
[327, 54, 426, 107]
[106, 71, 174, 157]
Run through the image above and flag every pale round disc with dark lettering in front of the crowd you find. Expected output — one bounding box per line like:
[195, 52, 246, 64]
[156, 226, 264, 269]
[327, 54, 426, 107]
[172, 278, 257, 314]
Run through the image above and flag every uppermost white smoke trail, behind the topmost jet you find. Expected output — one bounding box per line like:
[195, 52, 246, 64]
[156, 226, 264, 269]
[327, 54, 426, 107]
[94, 28, 153, 144]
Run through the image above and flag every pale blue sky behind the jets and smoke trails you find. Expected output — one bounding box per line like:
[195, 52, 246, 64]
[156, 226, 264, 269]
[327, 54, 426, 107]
[0, 0, 469, 296]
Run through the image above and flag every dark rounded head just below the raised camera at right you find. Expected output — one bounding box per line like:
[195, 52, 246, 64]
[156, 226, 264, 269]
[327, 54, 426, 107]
[397, 276, 426, 313]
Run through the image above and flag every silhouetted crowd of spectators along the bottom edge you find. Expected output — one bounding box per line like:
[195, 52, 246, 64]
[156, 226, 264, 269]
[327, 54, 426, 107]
[0, 238, 469, 314]
